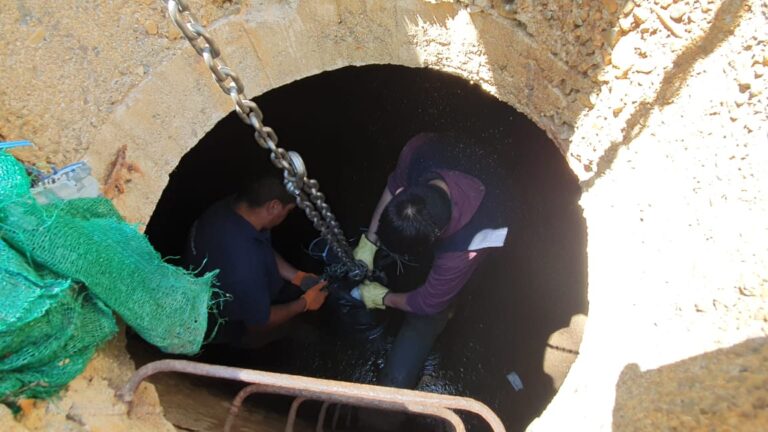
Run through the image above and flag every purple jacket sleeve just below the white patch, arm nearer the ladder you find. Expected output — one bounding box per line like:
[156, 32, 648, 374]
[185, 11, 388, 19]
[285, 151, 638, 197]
[406, 249, 489, 315]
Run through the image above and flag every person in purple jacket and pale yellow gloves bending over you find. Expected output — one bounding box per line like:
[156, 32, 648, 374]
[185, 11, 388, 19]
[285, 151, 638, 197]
[355, 133, 510, 388]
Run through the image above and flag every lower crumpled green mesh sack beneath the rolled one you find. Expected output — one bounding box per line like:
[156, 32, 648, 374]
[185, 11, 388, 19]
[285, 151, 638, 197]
[0, 204, 117, 402]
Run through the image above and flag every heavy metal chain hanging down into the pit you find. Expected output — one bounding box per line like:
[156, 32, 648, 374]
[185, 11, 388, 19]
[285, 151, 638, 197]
[168, 0, 368, 280]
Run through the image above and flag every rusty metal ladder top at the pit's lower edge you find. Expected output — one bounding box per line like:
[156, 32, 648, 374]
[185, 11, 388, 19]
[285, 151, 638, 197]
[118, 360, 505, 432]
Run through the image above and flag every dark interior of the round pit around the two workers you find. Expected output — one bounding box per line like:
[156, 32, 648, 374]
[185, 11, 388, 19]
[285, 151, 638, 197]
[129, 66, 587, 431]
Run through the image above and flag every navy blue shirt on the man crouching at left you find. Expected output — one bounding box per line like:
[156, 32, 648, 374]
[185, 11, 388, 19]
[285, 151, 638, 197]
[184, 197, 283, 342]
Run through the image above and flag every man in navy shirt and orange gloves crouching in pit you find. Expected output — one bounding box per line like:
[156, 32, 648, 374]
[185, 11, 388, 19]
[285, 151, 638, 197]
[189, 177, 327, 348]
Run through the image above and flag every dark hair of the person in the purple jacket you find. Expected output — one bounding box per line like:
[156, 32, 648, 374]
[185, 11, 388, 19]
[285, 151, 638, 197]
[376, 184, 451, 255]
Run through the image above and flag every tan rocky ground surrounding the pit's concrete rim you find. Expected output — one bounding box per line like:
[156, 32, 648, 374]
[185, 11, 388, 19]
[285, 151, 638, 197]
[0, 0, 768, 431]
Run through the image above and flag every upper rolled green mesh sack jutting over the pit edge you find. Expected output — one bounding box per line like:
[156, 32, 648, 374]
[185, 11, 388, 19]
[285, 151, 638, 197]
[0, 152, 212, 354]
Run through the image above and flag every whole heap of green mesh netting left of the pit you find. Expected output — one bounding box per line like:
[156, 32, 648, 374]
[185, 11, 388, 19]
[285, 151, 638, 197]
[0, 151, 212, 400]
